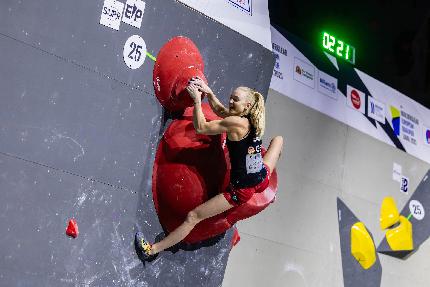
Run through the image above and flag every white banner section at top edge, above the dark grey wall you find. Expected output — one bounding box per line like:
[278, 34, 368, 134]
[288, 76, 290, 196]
[174, 0, 272, 50]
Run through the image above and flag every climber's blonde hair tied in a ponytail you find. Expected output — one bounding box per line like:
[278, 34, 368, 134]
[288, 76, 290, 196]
[239, 87, 266, 138]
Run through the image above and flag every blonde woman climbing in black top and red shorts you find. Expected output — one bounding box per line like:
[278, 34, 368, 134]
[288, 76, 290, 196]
[135, 78, 283, 259]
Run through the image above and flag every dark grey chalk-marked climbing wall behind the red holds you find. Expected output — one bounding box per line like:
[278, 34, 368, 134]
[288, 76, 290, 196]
[0, 0, 274, 286]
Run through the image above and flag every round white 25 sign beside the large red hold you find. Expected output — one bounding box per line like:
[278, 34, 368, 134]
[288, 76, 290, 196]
[123, 35, 146, 70]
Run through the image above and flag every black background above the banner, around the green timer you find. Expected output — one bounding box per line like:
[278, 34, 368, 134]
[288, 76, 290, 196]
[269, 0, 430, 108]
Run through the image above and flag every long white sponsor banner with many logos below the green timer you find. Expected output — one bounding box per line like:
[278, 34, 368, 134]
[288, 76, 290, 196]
[270, 27, 430, 165]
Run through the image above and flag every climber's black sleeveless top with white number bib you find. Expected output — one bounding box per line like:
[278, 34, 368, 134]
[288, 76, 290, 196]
[226, 120, 267, 188]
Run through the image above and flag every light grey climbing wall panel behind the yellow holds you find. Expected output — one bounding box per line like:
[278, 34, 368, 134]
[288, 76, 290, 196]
[223, 90, 430, 287]
